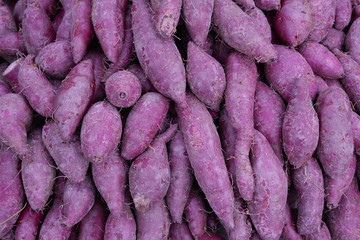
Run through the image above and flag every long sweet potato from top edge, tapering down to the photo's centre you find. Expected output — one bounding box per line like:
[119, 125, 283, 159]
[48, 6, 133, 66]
[131, 0, 186, 104]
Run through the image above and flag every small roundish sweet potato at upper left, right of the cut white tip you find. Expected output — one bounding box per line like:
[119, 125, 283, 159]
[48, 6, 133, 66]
[35, 41, 74, 79]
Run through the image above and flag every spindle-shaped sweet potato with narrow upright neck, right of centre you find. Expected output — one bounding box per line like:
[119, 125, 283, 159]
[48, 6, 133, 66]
[282, 78, 319, 168]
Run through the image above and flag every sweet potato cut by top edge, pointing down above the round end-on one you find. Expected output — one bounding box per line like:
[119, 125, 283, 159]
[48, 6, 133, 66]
[91, 0, 128, 62]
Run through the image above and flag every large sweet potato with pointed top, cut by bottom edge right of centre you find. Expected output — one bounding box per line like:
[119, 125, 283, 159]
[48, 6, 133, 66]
[248, 130, 288, 239]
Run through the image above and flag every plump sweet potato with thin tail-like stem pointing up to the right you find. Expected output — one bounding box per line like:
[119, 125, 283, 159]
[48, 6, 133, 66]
[129, 124, 178, 213]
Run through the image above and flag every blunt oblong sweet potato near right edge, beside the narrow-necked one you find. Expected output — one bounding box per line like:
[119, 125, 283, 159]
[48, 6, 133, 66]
[316, 87, 354, 178]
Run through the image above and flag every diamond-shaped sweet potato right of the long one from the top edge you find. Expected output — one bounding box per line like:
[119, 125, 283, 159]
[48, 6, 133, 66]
[186, 41, 226, 112]
